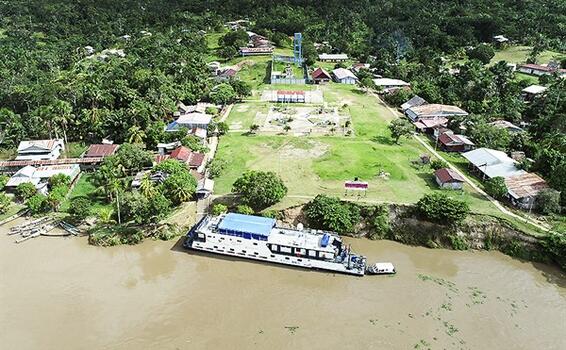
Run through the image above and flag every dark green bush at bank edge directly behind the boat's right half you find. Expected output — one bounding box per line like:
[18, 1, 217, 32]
[305, 195, 360, 233]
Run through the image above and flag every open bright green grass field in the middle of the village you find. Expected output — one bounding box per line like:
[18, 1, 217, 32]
[215, 84, 508, 213]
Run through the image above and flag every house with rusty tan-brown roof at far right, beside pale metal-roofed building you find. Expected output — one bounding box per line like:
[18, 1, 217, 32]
[505, 173, 548, 210]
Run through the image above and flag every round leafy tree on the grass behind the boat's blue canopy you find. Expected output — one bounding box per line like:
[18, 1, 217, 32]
[232, 170, 287, 209]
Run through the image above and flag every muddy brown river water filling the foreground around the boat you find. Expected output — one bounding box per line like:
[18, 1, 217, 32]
[0, 220, 566, 350]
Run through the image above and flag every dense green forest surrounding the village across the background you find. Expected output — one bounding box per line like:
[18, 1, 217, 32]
[0, 0, 566, 204]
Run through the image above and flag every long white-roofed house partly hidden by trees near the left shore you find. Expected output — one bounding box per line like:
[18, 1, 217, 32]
[6, 164, 81, 194]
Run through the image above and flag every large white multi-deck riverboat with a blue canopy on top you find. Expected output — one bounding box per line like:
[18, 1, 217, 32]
[183, 213, 366, 276]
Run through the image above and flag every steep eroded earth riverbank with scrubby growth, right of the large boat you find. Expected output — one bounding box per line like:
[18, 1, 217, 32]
[280, 203, 566, 270]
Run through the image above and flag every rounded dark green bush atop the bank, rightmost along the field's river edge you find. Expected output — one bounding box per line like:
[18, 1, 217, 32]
[416, 192, 470, 224]
